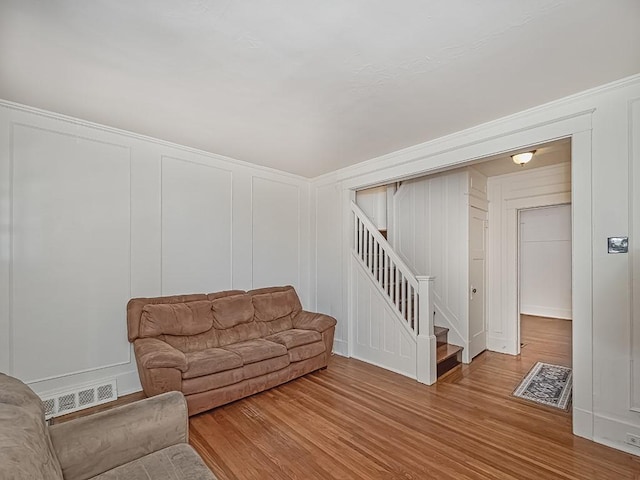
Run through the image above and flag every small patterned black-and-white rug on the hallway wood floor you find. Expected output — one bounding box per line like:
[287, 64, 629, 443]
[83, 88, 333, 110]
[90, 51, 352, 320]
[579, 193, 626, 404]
[513, 362, 573, 411]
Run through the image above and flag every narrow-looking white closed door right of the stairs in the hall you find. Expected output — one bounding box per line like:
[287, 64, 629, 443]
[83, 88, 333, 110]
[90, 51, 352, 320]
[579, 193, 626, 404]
[469, 207, 487, 358]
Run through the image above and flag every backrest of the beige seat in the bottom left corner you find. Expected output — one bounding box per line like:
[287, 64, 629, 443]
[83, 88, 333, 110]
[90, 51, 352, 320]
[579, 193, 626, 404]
[0, 373, 62, 480]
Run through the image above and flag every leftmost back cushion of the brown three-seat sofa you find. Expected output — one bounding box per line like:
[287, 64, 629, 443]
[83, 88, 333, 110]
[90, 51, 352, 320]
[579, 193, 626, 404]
[139, 300, 213, 338]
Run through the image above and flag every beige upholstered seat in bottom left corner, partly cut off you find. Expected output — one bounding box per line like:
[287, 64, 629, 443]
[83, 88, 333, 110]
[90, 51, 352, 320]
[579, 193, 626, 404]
[0, 374, 216, 480]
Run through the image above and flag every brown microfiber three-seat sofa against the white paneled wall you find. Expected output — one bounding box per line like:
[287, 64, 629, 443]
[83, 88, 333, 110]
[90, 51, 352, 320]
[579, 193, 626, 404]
[127, 286, 336, 415]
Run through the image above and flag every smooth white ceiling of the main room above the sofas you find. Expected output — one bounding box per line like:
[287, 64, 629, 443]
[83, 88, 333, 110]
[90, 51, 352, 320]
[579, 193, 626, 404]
[0, 0, 640, 177]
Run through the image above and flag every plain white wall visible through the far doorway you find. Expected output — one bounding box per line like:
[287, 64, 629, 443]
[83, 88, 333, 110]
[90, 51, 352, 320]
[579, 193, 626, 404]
[520, 205, 571, 319]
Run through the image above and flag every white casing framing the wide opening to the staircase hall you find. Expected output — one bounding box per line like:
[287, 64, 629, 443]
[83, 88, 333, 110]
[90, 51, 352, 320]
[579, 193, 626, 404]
[340, 114, 594, 439]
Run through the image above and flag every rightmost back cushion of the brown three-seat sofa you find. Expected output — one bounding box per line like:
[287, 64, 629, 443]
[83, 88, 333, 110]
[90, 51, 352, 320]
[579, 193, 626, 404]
[249, 286, 302, 335]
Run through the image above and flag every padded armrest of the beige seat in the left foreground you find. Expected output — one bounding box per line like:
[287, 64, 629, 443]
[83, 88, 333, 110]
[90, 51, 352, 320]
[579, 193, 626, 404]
[49, 392, 189, 480]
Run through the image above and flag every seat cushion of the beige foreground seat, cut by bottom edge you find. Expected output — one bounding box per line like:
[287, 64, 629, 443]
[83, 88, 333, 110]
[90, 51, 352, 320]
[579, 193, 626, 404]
[93, 443, 216, 480]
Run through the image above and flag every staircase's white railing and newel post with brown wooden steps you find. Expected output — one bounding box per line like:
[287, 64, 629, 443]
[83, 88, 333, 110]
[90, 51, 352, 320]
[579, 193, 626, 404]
[351, 203, 462, 385]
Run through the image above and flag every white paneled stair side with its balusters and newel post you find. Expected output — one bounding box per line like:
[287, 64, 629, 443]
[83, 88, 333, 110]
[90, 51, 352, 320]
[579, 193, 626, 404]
[350, 203, 436, 385]
